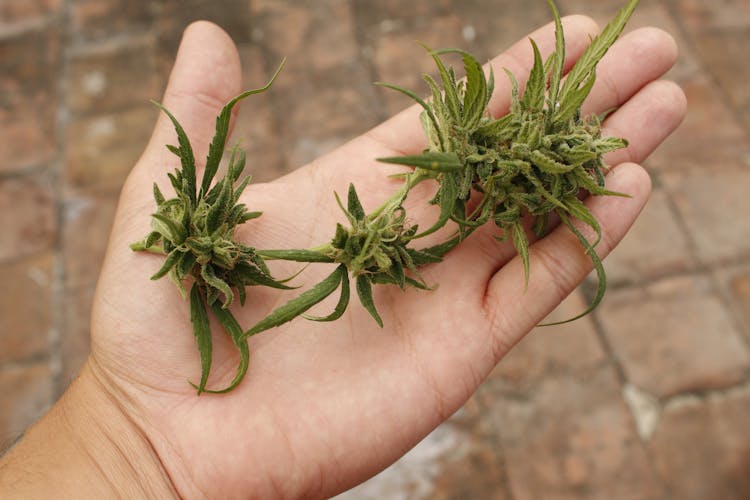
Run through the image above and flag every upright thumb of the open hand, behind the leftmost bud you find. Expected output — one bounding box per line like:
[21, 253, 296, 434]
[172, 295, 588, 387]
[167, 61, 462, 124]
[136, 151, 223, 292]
[124, 21, 242, 198]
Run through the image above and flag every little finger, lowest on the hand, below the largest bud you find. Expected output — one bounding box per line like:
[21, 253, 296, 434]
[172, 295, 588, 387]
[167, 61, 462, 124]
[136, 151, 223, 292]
[484, 163, 651, 357]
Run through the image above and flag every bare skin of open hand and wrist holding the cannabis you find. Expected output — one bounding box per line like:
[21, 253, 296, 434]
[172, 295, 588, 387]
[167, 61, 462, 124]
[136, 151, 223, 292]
[0, 16, 685, 498]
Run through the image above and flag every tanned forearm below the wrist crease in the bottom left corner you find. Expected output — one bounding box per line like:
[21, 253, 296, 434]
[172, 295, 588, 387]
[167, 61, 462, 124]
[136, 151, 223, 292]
[0, 365, 177, 498]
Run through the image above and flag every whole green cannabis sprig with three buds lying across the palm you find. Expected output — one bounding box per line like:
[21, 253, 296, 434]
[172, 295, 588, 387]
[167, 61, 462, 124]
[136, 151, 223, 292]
[132, 0, 638, 394]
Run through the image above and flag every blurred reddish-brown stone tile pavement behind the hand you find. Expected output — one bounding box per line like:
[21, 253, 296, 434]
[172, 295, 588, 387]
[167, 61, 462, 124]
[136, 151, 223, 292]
[0, 0, 750, 500]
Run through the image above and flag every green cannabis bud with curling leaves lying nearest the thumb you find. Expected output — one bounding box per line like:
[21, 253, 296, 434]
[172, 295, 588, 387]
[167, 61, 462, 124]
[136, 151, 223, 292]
[131, 62, 290, 394]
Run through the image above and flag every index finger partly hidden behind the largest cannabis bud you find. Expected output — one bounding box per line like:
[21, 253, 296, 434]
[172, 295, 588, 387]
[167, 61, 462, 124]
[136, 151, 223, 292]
[367, 16, 599, 154]
